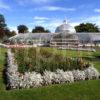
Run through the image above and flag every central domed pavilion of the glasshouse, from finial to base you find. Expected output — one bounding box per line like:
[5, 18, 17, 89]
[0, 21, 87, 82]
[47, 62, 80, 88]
[50, 21, 79, 48]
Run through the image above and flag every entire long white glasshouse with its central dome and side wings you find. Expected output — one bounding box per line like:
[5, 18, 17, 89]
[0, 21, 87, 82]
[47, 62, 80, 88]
[9, 21, 100, 48]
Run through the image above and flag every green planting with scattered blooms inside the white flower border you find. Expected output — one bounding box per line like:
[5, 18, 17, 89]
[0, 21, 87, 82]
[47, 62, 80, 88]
[12, 48, 89, 74]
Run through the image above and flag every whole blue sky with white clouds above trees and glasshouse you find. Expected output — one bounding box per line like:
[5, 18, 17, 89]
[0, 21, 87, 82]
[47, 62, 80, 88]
[0, 0, 100, 32]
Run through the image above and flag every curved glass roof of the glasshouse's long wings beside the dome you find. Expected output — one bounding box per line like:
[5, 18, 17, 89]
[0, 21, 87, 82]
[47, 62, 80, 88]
[9, 32, 100, 43]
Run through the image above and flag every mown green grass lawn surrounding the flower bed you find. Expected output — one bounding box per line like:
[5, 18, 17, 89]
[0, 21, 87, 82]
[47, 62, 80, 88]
[0, 48, 100, 100]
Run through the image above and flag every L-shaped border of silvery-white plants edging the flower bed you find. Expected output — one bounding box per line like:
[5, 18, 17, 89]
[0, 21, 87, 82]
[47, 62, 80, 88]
[6, 49, 100, 89]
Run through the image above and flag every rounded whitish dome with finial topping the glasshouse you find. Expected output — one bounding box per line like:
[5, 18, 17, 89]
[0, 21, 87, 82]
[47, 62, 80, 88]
[55, 20, 76, 34]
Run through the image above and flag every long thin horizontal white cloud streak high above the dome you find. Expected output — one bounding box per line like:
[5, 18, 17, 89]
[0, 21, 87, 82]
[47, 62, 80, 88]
[35, 6, 76, 11]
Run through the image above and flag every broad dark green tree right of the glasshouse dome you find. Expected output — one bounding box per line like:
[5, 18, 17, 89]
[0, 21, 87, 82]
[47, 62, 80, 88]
[75, 23, 100, 32]
